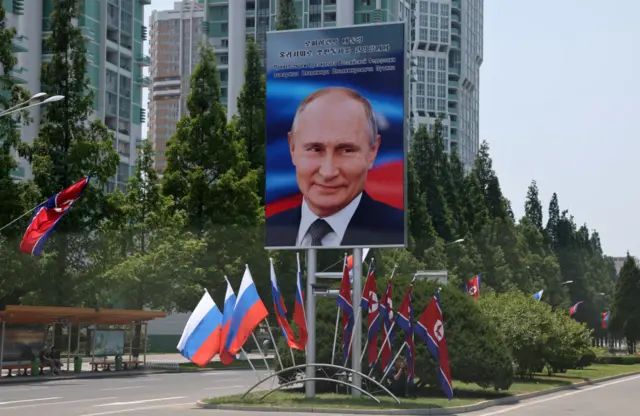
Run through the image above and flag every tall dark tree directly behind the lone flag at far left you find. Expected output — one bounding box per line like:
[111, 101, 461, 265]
[21, 0, 118, 306]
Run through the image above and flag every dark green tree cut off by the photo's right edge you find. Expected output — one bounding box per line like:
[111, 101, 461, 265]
[609, 253, 640, 352]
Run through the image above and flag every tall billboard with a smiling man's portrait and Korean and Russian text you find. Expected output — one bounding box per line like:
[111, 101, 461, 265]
[265, 22, 408, 249]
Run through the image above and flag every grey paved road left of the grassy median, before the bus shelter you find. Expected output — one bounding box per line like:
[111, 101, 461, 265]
[0, 370, 272, 416]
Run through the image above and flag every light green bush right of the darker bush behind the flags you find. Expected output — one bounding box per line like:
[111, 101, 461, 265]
[480, 291, 595, 377]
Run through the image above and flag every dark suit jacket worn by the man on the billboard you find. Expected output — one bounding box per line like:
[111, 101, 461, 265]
[265, 192, 404, 248]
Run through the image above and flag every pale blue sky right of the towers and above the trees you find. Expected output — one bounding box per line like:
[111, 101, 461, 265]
[143, 0, 640, 256]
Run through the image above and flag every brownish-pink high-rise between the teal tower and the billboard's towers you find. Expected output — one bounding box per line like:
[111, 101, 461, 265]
[147, 1, 202, 174]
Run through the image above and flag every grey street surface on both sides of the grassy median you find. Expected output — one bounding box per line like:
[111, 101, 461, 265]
[0, 370, 640, 416]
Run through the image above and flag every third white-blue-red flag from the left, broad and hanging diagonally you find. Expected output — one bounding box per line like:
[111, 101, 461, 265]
[227, 265, 269, 355]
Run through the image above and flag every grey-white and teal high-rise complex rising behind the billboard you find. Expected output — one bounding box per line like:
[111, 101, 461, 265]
[150, 0, 484, 168]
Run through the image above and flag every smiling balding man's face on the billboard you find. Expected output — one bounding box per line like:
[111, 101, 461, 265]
[289, 92, 380, 217]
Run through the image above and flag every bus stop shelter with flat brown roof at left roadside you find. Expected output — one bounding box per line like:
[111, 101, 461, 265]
[0, 305, 167, 374]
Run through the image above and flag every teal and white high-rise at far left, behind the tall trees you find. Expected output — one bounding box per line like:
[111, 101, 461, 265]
[2, 0, 151, 190]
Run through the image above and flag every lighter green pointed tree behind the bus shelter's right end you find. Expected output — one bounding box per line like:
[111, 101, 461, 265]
[96, 142, 205, 357]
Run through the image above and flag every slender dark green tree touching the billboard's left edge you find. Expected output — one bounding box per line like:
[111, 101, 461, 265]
[235, 40, 267, 204]
